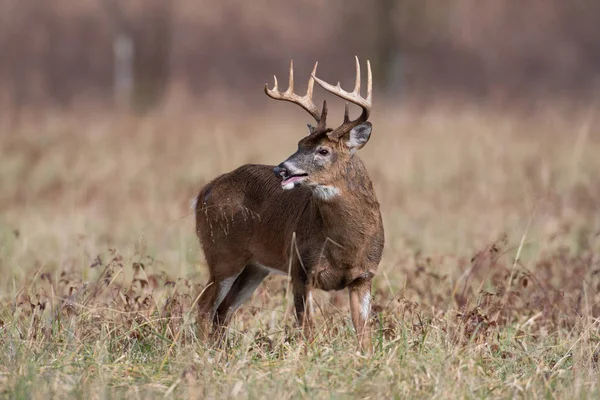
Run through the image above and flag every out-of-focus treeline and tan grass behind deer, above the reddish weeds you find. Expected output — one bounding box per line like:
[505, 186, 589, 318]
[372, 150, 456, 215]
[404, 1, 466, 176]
[0, 0, 600, 286]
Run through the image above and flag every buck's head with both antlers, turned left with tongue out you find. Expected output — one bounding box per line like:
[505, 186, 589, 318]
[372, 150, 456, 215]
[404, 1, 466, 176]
[265, 57, 372, 199]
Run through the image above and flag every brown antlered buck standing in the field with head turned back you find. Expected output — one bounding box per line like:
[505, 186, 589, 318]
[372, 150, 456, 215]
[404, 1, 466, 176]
[194, 56, 384, 351]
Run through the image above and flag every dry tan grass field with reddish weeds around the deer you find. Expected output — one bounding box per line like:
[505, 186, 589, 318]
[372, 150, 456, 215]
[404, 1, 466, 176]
[0, 103, 600, 399]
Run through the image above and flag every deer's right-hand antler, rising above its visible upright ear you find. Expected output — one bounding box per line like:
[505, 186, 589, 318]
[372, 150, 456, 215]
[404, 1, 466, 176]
[312, 56, 373, 139]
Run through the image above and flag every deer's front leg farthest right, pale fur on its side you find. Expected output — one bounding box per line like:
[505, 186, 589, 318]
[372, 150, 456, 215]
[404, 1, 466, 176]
[348, 278, 371, 352]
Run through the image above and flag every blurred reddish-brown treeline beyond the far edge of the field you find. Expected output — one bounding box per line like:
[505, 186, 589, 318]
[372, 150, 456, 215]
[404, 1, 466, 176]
[0, 0, 600, 112]
